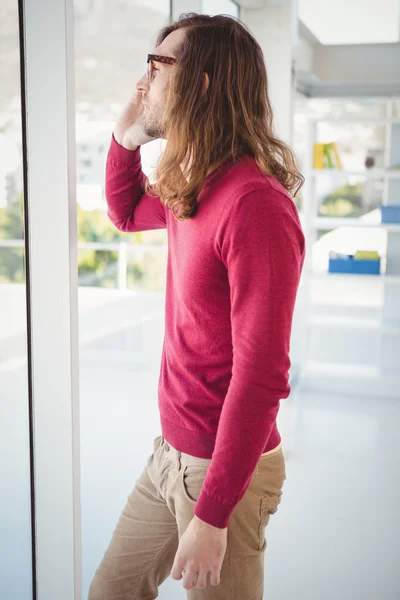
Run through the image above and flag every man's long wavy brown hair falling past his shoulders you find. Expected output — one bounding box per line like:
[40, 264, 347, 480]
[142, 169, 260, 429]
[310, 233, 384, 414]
[146, 13, 304, 221]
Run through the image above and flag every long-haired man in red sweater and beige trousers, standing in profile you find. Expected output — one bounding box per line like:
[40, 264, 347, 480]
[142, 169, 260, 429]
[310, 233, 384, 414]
[89, 14, 304, 600]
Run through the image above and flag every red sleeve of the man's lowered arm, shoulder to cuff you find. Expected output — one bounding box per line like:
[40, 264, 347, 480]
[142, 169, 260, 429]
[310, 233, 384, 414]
[195, 184, 305, 528]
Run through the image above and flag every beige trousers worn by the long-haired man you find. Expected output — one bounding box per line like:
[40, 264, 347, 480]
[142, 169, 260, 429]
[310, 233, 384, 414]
[88, 436, 286, 600]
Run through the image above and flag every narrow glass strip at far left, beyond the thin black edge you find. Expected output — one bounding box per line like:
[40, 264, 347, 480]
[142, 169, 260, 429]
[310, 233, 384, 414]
[0, 0, 32, 600]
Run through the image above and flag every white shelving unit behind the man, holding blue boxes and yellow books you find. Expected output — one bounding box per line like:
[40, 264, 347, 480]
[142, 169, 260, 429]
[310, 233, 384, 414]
[300, 111, 400, 384]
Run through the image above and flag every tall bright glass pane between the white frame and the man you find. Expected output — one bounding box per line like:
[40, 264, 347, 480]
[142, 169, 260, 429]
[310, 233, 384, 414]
[74, 0, 170, 598]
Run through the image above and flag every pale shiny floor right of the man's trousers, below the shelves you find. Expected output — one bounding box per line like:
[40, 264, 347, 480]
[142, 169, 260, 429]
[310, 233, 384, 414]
[258, 394, 400, 600]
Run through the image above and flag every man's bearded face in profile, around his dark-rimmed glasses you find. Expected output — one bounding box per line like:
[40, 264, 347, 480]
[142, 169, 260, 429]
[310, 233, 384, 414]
[136, 28, 185, 138]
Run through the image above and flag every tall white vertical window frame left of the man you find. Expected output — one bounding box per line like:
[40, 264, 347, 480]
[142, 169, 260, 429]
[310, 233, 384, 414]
[19, 0, 82, 600]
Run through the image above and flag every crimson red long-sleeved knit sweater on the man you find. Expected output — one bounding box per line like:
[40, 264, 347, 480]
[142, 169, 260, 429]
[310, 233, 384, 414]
[106, 136, 305, 528]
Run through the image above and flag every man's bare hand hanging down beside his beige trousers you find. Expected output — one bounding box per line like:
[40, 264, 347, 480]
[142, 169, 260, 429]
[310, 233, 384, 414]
[171, 516, 228, 590]
